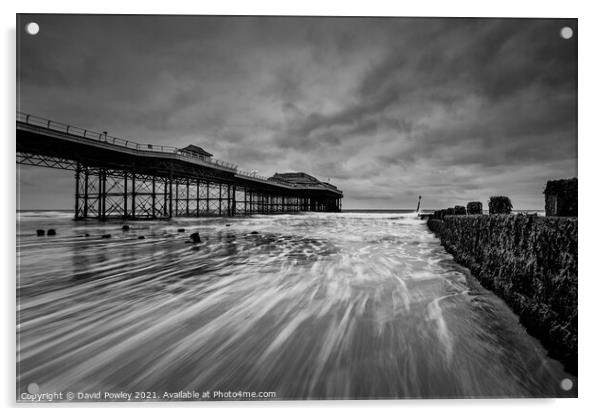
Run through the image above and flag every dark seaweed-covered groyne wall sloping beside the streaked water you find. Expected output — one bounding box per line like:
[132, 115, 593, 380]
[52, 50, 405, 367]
[427, 215, 577, 375]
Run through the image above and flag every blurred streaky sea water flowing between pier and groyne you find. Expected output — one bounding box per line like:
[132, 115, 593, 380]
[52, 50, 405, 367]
[17, 212, 576, 399]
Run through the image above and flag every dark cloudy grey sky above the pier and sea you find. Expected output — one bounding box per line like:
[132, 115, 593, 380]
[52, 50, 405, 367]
[17, 15, 577, 209]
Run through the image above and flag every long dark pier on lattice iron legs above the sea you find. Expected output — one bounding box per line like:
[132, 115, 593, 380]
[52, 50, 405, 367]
[16, 112, 343, 220]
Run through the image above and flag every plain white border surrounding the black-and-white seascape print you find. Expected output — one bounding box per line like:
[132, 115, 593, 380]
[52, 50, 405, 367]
[0, 0, 602, 416]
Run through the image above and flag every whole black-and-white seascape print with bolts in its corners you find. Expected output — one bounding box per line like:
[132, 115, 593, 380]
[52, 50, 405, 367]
[16, 13, 585, 404]
